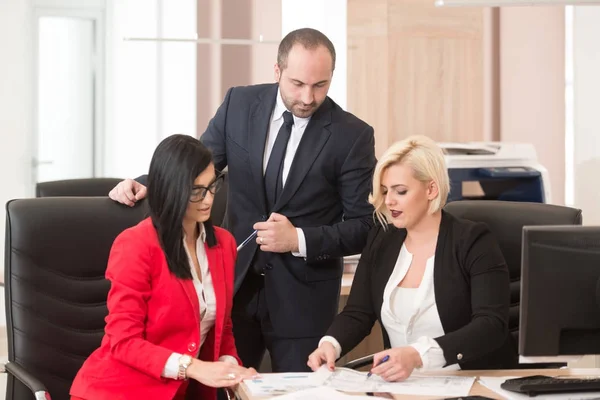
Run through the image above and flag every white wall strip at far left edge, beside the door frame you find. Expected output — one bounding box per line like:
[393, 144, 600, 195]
[0, 0, 33, 279]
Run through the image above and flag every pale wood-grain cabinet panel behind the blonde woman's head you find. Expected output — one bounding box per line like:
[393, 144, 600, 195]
[347, 0, 491, 156]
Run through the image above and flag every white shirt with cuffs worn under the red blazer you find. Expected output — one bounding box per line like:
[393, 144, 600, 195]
[162, 224, 238, 379]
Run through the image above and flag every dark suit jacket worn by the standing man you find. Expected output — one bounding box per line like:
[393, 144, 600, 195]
[200, 84, 376, 338]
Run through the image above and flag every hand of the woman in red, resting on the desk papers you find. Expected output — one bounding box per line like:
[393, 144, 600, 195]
[187, 359, 258, 388]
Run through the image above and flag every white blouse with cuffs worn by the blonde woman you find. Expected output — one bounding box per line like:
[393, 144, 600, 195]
[319, 245, 460, 370]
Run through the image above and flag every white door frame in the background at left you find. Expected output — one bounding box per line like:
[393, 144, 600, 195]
[31, 0, 106, 187]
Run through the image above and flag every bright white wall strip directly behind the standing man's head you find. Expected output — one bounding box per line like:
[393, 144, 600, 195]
[281, 0, 348, 110]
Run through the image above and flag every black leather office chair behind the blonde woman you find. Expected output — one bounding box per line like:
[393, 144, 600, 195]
[345, 200, 582, 368]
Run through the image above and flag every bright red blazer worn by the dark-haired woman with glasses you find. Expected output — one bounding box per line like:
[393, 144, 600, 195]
[70, 218, 241, 400]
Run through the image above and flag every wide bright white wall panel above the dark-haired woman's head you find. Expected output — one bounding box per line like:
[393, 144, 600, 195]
[104, 0, 196, 178]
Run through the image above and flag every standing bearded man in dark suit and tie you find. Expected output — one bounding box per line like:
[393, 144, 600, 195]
[109, 28, 376, 372]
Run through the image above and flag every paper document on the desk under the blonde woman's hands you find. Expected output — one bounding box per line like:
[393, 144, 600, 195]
[311, 367, 475, 397]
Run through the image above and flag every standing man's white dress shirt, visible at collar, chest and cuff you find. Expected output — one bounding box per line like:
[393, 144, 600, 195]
[263, 89, 310, 257]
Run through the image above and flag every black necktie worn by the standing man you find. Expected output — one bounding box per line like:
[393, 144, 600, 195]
[265, 111, 294, 211]
